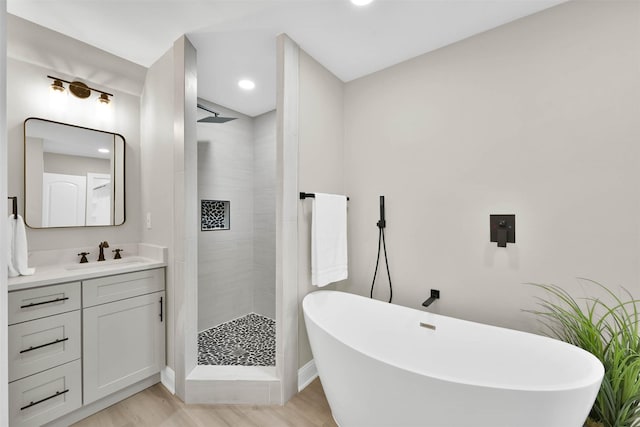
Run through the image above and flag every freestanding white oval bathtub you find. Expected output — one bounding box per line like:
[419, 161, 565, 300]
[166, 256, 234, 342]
[302, 291, 604, 427]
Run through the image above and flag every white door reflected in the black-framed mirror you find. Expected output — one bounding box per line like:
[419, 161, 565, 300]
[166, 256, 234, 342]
[42, 173, 87, 227]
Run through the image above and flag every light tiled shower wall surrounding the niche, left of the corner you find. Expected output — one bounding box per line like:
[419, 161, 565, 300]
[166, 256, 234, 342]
[197, 100, 254, 331]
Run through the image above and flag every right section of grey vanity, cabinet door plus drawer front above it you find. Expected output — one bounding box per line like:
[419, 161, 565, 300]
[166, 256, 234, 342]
[82, 270, 166, 405]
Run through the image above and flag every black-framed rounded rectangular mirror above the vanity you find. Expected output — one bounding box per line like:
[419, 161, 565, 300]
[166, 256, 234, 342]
[24, 117, 126, 228]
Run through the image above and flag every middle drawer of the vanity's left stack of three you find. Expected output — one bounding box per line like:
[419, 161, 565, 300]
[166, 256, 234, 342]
[9, 310, 81, 382]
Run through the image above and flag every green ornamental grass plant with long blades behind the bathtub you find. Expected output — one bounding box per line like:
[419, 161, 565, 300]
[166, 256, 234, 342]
[527, 279, 640, 427]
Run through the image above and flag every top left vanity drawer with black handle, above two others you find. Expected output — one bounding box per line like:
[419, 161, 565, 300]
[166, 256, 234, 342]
[9, 282, 80, 325]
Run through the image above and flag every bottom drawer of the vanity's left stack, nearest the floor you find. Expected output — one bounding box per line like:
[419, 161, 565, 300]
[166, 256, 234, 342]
[9, 360, 82, 427]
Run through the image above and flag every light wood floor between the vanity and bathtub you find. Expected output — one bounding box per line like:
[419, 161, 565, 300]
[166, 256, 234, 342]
[73, 379, 337, 427]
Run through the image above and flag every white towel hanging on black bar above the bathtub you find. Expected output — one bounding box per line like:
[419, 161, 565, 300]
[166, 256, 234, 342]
[311, 193, 348, 286]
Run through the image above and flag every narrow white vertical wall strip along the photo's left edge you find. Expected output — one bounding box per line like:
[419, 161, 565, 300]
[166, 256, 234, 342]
[0, 0, 9, 426]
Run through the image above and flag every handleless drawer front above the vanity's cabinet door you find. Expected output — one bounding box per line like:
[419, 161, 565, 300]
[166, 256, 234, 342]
[82, 268, 164, 308]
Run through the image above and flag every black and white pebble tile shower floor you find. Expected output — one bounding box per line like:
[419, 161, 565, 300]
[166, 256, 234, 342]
[198, 313, 276, 366]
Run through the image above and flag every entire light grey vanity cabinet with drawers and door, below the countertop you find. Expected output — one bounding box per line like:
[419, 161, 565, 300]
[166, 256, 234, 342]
[9, 268, 166, 427]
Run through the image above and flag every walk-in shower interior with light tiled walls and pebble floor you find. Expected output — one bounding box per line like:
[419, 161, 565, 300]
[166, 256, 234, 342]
[197, 99, 276, 366]
